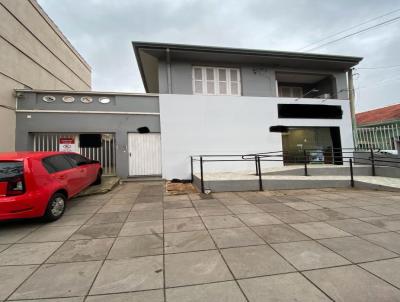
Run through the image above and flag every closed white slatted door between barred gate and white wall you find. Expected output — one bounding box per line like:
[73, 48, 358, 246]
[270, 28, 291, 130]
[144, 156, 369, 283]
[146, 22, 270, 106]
[128, 133, 161, 176]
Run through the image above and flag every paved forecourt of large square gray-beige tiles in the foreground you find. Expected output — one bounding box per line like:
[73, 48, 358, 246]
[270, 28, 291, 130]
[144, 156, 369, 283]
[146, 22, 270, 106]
[0, 183, 400, 302]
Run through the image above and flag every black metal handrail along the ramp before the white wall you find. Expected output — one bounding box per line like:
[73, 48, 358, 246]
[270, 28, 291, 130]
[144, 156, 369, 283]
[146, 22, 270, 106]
[190, 148, 400, 193]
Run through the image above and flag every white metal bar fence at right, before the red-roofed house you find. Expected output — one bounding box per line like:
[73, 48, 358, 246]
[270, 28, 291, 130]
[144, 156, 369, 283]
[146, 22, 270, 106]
[356, 125, 400, 150]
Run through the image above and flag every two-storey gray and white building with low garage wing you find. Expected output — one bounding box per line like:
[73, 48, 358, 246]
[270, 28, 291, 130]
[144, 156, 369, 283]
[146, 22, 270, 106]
[16, 42, 361, 179]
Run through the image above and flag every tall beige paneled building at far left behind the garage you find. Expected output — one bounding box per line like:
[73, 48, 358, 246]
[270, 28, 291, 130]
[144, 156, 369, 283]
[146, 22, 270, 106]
[0, 0, 91, 152]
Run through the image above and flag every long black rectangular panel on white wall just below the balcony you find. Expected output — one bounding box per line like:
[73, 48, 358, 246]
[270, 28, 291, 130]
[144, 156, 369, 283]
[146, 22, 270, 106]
[278, 104, 343, 119]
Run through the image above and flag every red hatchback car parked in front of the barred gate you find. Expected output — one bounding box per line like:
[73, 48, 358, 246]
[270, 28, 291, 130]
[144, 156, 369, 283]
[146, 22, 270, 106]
[0, 152, 102, 221]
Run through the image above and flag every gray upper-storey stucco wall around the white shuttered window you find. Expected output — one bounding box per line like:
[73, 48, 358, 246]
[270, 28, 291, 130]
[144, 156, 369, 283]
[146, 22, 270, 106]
[158, 61, 348, 100]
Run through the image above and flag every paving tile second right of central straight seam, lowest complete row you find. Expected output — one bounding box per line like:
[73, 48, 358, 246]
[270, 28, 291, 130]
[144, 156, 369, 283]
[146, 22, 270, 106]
[221, 245, 295, 279]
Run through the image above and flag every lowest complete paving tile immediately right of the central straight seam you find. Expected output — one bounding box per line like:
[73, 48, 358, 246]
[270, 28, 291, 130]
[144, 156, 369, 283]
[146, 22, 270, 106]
[165, 251, 233, 287]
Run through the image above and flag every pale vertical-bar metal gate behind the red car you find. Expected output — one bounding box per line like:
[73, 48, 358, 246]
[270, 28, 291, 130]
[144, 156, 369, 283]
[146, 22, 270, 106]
[33, 133, 115, 175]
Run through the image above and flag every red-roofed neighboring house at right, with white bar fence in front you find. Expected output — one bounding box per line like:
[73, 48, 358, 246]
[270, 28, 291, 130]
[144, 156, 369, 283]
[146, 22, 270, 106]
[356, 104, 400, 150]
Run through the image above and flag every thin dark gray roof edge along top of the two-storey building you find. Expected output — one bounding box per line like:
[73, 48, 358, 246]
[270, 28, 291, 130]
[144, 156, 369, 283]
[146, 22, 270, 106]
[132, 41, 363, 65]
